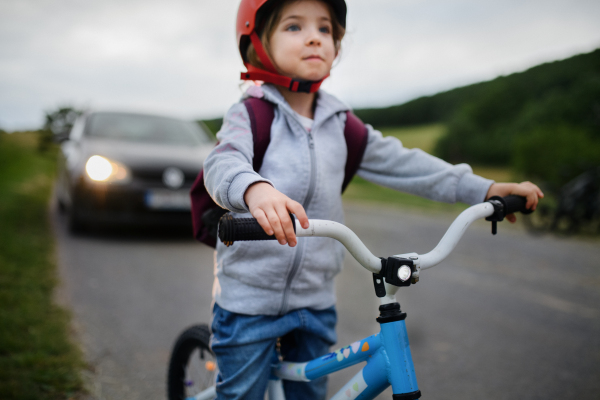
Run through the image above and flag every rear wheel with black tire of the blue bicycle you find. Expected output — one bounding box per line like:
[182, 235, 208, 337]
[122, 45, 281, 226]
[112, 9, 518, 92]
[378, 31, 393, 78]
[167, 324, 217, 400]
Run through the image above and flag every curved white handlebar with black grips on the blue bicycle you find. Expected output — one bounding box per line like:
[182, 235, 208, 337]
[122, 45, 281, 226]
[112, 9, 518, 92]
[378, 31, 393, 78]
[218, 195, 532, 277]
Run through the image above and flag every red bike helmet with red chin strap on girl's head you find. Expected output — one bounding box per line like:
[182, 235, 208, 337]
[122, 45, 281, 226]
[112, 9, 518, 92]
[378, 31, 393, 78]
[235, 0, 346, 93]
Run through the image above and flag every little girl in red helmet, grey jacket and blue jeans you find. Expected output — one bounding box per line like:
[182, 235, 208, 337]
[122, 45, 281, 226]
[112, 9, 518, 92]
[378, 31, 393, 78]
[204, 0, 543, 400]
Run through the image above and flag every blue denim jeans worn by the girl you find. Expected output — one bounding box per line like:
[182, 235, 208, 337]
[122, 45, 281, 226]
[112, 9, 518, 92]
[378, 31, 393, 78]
[211, 304, 337, 400]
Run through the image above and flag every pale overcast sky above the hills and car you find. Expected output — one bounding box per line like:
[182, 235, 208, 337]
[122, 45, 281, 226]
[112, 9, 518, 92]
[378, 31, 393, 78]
[0, 0, 600, 131]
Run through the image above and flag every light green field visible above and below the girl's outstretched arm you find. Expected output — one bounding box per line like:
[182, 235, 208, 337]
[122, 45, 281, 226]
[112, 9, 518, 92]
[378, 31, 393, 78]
[344, 124, 512, 212]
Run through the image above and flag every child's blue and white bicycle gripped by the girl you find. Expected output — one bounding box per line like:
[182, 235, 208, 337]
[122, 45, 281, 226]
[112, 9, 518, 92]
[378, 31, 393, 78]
[167, 196, 530, 400]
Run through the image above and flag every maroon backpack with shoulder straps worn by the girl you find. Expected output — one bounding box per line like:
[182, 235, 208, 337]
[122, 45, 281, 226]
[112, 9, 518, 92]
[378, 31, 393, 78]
[190, 97, 369, 247]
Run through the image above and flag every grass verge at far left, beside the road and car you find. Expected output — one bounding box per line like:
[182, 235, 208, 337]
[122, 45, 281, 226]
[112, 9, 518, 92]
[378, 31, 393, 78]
[0, 131, 84, 399]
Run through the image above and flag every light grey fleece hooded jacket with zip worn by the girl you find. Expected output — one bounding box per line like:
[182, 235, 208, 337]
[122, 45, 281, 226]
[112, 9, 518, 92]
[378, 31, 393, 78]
[204, 84, 493, 315]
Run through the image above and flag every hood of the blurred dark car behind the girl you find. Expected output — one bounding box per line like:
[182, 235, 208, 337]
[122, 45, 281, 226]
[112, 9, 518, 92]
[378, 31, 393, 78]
[81, 139, 214, 172]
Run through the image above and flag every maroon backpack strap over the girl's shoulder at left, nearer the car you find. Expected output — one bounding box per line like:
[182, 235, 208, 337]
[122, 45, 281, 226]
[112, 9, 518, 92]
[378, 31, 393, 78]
[244, 97, 275, 172]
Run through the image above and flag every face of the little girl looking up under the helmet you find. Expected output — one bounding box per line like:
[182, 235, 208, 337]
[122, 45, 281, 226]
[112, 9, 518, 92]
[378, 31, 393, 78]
[270, 0, 336, 81]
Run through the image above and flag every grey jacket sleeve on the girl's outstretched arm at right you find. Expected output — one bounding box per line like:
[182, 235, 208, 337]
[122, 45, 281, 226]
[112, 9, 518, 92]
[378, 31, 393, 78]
[357, 125, 494, 204]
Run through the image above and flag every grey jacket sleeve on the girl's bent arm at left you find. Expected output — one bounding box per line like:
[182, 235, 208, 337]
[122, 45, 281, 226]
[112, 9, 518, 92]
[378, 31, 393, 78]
[204, 103, 273, 213]
